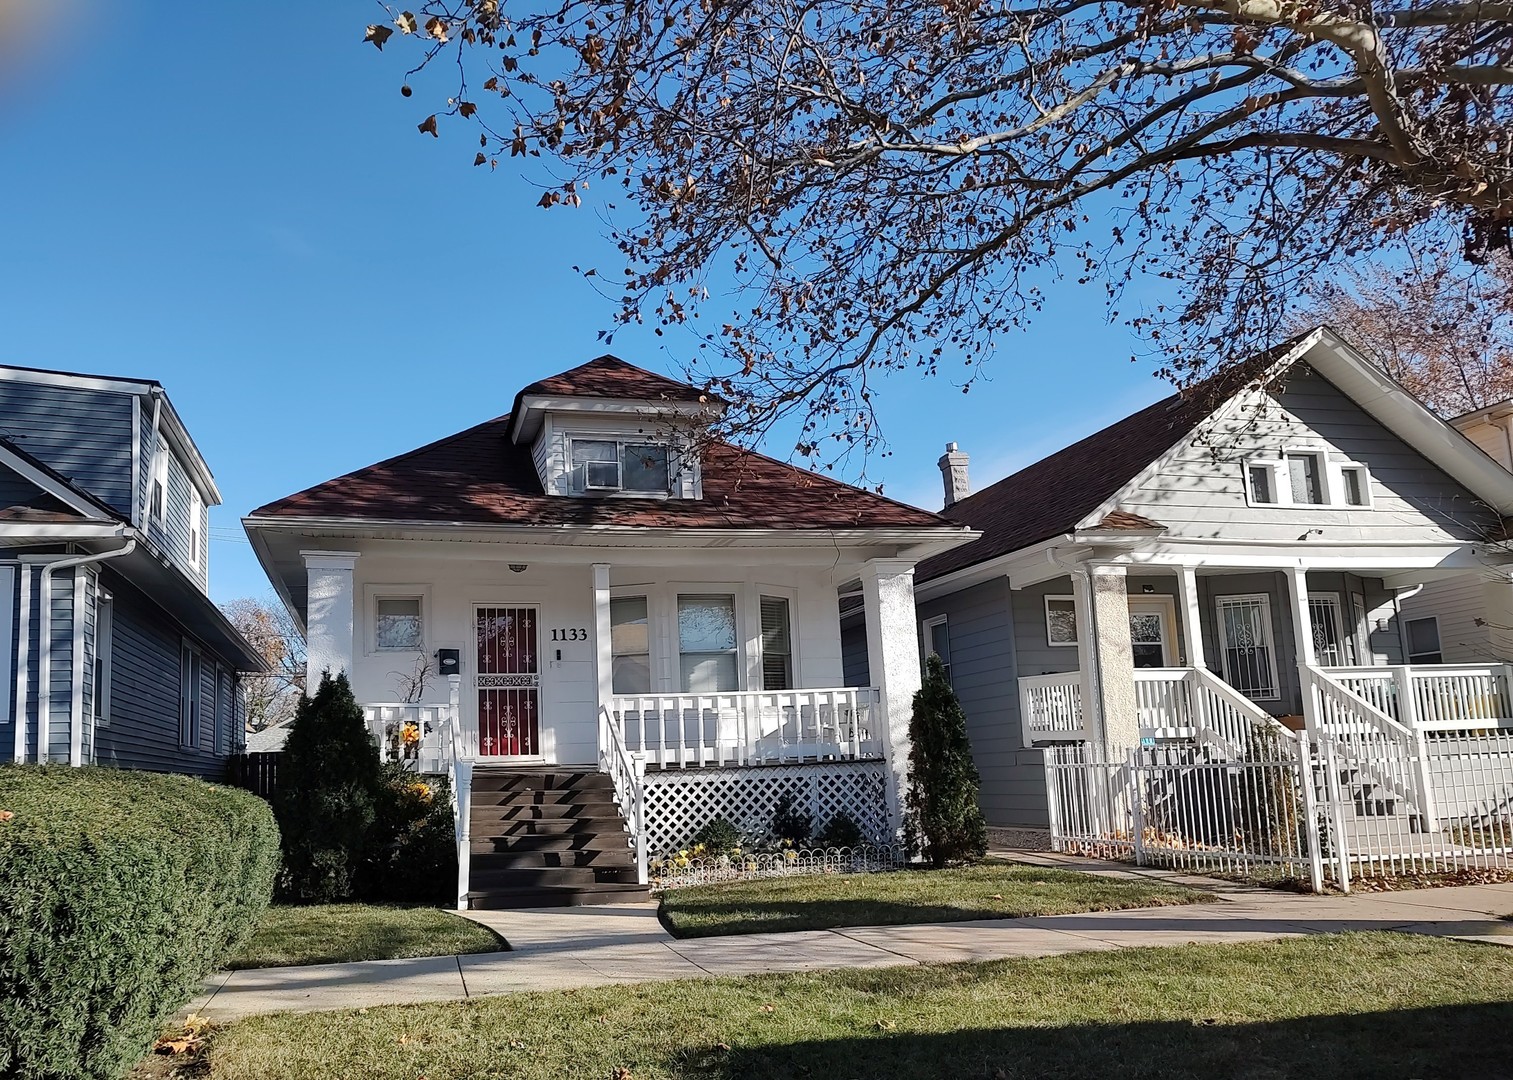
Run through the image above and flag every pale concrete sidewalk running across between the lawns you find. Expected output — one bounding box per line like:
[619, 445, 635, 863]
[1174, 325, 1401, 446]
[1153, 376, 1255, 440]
[189, 877, 1513, 1021]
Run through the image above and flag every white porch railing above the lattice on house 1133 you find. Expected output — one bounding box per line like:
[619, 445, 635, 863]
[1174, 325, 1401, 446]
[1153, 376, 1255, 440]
[601, 687, 882, 768]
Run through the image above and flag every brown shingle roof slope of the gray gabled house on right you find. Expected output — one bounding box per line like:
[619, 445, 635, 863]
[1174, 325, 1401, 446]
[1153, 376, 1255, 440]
[915, 338, 1313, 582]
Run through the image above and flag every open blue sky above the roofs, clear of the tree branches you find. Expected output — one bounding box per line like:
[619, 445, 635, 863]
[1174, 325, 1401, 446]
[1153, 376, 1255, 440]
[0, 0, 1170, 601]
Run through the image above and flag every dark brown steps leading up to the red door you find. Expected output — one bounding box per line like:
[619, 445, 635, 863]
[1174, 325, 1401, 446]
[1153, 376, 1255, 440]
[468, 767, 649, 909]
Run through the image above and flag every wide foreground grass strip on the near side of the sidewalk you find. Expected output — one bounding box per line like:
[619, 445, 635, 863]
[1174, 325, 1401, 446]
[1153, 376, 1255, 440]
[207, 933, 1513, 1080]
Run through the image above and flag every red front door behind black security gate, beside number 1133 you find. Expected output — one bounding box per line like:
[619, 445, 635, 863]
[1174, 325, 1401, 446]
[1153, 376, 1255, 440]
[474, 607, 542, 758]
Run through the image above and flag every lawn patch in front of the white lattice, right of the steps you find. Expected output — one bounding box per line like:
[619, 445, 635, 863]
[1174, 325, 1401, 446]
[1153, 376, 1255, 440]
[661, 859, 1213, 938]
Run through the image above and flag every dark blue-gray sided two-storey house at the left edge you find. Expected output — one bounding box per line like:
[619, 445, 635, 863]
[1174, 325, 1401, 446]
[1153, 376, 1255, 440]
[0, 366, 265, 777]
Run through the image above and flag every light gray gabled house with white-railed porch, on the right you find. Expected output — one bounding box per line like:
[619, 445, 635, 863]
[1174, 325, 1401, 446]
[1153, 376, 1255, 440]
[844, 328, 1513, 827]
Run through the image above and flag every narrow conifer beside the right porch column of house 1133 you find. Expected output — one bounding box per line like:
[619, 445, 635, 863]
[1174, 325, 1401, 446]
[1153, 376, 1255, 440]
[903, 655, 988, 870]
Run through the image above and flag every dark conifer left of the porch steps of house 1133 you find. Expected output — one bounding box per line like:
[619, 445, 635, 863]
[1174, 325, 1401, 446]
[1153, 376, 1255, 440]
[274, 672, 383, 903]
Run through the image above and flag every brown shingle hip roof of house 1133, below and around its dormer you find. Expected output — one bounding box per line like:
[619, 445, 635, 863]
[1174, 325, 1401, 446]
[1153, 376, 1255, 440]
[253, 411, 950, 529]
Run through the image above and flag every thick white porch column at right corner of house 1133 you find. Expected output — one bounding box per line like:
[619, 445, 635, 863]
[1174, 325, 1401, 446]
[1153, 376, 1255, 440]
[861, 558, 920, 829]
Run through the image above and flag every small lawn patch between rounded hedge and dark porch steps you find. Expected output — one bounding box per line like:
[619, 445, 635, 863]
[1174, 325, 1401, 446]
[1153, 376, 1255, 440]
[225, 903, 508, 968]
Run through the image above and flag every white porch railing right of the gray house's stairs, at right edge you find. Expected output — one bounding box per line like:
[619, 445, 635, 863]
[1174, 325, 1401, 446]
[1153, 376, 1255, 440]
[1321, 664, 1513, 731]
